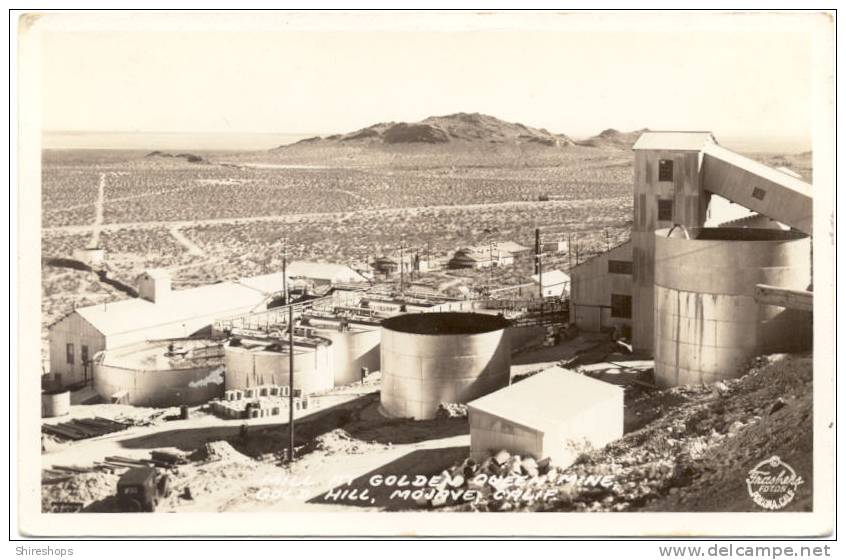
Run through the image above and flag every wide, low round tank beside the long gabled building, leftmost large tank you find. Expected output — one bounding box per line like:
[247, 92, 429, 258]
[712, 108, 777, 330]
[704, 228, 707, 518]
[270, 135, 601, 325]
[94, 339, 224, 407]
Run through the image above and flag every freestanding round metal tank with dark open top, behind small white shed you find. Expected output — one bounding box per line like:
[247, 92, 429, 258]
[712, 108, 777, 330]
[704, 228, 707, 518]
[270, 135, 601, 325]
[381, 313, 511, 419]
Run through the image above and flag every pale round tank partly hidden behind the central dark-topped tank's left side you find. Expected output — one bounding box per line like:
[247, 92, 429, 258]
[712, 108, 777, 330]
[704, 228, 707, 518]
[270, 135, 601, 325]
[309, 317, 381, 387]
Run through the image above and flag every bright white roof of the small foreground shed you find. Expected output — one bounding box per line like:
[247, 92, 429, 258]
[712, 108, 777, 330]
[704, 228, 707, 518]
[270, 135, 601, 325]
[467, 366, 623, 431]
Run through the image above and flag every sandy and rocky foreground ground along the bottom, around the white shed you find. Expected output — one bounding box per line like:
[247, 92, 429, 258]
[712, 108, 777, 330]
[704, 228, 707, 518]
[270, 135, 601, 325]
[42, 355, 813, 512]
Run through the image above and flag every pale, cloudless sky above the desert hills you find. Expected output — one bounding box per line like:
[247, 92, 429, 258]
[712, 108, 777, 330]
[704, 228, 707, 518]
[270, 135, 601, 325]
[36, 13, 824, 148]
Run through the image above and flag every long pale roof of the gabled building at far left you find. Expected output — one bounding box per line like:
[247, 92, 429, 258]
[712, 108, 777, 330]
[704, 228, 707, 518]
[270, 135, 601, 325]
[76, 282, 266, 336]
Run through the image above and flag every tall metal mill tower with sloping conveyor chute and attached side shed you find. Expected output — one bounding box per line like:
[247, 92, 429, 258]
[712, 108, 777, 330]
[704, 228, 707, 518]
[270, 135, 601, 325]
[568, 131, 813, 355]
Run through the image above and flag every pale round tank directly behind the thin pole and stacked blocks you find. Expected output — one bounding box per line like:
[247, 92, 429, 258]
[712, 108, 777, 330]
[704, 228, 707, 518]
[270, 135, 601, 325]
[224, 339, 334, 395]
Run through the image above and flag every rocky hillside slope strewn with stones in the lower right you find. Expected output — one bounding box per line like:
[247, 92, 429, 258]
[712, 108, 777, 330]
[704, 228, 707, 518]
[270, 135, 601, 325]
[448, 355, 812, 512]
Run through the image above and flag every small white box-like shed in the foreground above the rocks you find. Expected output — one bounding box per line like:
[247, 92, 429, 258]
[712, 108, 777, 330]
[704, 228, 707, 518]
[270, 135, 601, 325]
[467, 367, 623, 467]
